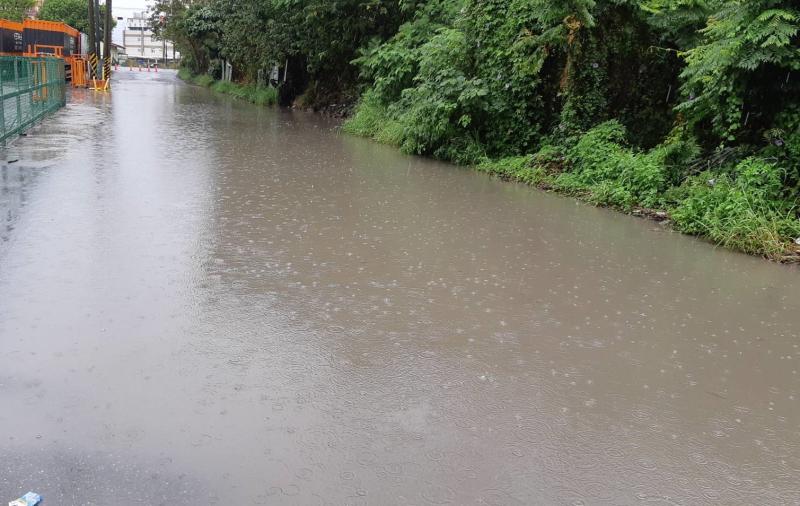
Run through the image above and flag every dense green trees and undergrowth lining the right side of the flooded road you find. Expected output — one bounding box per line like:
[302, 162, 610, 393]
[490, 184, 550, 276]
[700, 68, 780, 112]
[158, 0, 800, 260]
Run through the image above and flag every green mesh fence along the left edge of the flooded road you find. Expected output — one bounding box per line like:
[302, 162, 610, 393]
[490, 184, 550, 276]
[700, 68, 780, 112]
[0, 56, 66, 143]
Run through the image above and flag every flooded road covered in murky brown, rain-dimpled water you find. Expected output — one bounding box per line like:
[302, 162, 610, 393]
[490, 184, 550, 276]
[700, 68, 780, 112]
[0, 71, 800, 505]
